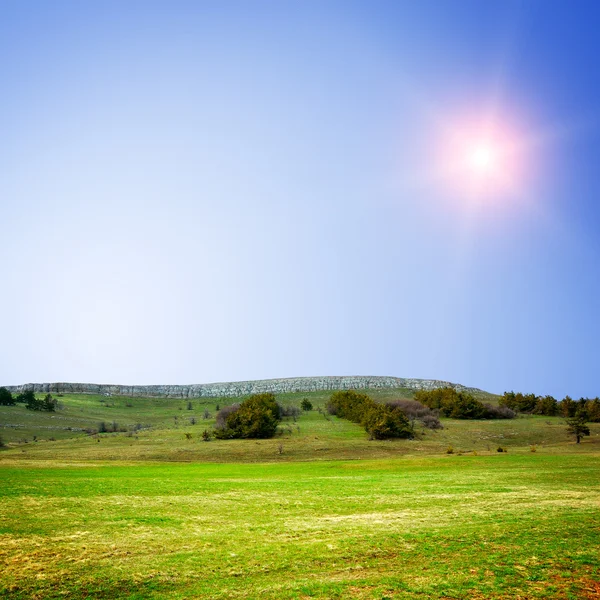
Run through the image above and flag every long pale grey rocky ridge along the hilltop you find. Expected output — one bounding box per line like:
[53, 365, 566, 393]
[2, 376, 482, 398]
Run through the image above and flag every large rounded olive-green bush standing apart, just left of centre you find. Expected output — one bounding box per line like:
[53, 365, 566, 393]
[215, 393, 281, 439]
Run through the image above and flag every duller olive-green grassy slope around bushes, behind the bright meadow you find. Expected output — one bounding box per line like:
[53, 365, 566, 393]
[0, 389, 600, 462]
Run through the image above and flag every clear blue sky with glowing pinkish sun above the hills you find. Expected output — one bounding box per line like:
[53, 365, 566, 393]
[0, 0, 600, 398]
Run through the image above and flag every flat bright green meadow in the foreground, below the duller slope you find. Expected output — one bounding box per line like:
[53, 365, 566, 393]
[0, 453, 600, 599]
